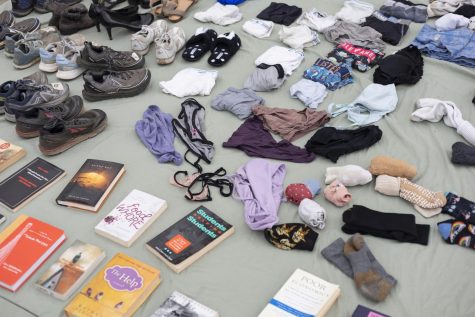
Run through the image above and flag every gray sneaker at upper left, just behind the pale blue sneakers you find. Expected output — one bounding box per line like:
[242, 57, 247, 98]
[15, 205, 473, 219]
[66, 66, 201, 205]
[13, 26, 61, 69]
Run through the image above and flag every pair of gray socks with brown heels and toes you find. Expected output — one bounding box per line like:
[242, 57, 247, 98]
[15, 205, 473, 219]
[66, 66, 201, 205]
[321, 234, 397, 302]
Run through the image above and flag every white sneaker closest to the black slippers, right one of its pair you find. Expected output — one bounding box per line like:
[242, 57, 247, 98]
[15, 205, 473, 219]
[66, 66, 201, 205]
[155, 26, 185, 65]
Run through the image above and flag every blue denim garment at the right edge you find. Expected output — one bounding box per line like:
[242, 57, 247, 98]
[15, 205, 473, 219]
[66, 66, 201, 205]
[412, 24, 475, 67]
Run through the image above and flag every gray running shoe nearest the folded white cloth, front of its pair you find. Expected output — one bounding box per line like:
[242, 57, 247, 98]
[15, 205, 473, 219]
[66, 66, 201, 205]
[82, 68, 151, 101]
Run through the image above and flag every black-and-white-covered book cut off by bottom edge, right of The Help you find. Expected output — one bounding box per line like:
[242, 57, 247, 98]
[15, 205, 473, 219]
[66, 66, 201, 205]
[150, 291, 219, 317]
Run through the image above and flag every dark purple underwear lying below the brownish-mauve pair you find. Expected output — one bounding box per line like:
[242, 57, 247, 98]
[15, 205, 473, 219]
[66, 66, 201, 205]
[223, 116, 315, 163]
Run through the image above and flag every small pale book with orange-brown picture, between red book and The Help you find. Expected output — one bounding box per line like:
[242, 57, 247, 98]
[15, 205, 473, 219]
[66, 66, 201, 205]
[35, 240, 106, 300]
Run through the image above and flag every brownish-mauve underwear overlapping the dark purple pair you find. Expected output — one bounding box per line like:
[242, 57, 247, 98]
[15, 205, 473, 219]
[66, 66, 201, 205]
[252, 106, 330, 142]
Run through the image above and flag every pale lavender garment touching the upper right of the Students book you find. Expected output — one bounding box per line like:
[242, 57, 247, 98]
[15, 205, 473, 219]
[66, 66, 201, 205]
[230, 159, 286, 230]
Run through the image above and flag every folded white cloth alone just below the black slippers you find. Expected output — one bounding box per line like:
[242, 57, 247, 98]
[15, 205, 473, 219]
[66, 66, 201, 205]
[159, 68, 218, 98]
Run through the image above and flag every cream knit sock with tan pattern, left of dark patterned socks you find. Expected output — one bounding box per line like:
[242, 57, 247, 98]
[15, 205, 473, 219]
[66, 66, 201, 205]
[399, 178, 447, 209]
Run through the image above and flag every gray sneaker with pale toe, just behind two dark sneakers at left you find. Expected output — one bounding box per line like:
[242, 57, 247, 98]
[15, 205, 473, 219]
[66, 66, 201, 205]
[4, 80, 69, 122]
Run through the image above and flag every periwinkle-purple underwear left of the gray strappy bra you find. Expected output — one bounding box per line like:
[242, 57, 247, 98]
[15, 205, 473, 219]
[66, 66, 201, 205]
[135, 105, 183, 165]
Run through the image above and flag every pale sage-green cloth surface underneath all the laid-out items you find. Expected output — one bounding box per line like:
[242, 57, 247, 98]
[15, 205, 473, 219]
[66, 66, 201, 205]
[0, 0, 475, 317]
